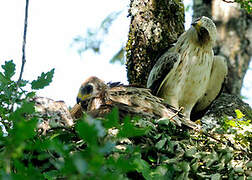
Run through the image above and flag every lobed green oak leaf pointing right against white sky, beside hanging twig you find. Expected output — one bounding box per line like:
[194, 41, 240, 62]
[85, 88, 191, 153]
[31, 69, 54, 89]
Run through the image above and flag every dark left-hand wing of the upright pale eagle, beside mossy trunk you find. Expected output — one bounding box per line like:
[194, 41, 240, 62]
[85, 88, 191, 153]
[147, 49, 180, 94]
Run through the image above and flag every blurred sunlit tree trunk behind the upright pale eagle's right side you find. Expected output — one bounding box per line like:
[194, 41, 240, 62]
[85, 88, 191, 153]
[193, 0, 252, 96]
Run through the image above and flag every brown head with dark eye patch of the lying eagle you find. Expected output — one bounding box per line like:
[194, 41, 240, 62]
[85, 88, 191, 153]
[76, 76, 106, 109]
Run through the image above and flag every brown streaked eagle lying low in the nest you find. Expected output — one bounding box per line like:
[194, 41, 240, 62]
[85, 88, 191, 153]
[71, 77, 198, 128]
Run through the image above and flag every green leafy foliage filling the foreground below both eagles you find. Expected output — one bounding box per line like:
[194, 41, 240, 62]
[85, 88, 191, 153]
[0, 61, 252, 179]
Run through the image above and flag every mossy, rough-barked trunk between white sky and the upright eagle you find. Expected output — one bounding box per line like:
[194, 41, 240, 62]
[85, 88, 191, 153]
[126, 0, 185, 87]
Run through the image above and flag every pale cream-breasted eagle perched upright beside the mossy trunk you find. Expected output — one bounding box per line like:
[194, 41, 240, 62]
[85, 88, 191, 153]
[147, 16, 227, 119]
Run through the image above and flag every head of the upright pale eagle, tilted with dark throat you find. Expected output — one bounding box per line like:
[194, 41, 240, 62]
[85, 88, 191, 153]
[192, 16, 217, 46]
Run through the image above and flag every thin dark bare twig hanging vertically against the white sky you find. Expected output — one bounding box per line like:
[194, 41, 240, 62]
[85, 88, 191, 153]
[17, 0, 29, 84]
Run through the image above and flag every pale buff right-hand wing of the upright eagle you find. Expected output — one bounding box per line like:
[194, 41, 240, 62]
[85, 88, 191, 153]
[194, 56, 228, 112]
